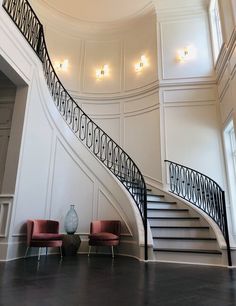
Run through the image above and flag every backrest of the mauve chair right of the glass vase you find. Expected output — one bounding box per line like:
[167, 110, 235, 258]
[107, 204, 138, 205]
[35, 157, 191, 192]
[90, 220, 121, 236]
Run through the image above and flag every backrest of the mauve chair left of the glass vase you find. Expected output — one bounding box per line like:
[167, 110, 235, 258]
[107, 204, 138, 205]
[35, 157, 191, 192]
[27, 219, 59, 245]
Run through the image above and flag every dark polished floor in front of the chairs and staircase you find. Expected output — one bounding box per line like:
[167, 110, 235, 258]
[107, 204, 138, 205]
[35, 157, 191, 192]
[0, 255, 236, 306]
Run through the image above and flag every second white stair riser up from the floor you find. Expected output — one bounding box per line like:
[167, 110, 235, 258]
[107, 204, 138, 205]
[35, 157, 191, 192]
[154, 239, 218, 250]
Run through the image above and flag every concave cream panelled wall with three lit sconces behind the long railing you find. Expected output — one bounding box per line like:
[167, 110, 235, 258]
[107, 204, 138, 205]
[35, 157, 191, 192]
[31, 1, 162, 185]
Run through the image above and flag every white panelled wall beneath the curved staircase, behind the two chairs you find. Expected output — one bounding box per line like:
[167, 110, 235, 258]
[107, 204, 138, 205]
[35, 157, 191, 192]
[0, 5, 143, 259]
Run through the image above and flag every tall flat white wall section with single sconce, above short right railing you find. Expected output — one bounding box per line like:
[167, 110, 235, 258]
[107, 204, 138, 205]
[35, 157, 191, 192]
[156, 1, 225, 188]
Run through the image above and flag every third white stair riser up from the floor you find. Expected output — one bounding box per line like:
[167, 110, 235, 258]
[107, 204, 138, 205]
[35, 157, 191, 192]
[151, 228, 213, 238]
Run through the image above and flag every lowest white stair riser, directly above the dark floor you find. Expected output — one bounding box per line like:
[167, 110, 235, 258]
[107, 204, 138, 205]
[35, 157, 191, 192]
[154, 252, 222, 265]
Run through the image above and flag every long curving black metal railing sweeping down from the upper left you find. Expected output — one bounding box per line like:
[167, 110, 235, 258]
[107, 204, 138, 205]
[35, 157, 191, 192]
[3, 0, 148, 260]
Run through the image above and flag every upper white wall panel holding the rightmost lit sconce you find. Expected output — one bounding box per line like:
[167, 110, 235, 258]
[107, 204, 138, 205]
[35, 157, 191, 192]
[160, 14, 213, 82]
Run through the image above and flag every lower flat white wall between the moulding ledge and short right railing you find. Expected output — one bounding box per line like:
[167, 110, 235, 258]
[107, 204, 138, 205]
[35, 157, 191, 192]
[164, 87, 225, 188]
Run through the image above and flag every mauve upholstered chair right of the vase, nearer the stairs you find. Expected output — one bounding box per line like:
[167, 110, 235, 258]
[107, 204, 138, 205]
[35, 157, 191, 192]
[88, 220, 121, 258]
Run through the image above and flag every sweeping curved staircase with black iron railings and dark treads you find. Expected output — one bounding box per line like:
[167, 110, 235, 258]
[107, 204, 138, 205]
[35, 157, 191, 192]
[3, 0, 231, 265]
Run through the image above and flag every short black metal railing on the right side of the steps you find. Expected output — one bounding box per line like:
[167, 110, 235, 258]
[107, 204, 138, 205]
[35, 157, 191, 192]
[165, 160, 232, 266]
